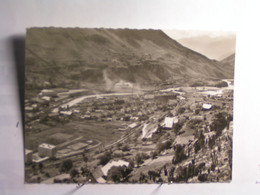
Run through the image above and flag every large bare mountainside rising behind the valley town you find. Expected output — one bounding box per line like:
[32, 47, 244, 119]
[25, 28, 233, 90]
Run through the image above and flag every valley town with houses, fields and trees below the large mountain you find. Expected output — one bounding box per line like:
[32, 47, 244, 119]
[25, 79, 233, 183]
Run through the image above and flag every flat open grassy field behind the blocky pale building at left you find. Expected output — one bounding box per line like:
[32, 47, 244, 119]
[25, 120, 128, 151]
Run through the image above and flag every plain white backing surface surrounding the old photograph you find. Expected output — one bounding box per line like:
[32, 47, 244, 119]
[0, 0, 260, 194]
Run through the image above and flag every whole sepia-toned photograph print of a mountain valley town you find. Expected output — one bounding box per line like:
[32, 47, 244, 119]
[24, 27, 236, 184]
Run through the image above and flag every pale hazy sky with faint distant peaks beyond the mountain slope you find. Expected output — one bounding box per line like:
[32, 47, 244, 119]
[164, 30, 236, 60]
